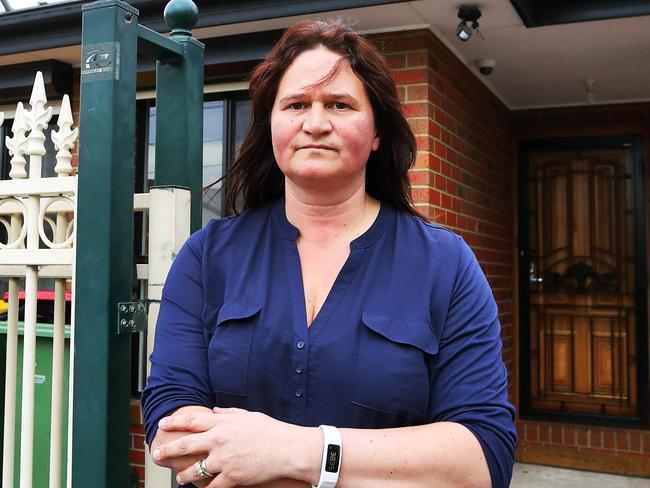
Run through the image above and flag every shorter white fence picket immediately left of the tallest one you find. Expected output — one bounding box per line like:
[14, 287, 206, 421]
[2, 102, 27, 488]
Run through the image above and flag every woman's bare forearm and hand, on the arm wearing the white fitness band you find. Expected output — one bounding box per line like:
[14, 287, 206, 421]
[154, 409, 491, 488]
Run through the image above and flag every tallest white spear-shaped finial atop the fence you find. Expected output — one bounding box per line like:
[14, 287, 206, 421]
[25, 71, 52, 178]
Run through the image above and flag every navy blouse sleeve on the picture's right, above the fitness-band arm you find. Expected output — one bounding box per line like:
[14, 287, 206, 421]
[429, 237, 517, 488]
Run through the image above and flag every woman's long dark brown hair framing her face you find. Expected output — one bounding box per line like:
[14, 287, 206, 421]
[224, 20, 418, 215]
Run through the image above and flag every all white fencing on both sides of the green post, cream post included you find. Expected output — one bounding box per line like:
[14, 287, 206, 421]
[0, 72, 190, 488]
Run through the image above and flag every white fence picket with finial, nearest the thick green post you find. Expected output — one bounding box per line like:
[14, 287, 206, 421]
[49, 95, 79, 488]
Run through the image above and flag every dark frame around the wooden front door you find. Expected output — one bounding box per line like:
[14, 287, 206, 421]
[517, 134, 650, 427]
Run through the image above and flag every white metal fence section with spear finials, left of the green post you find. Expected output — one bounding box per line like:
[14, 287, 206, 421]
[0, 72, 78, 488]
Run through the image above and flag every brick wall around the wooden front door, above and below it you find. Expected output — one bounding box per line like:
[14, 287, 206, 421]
[512, 103, 650, 476]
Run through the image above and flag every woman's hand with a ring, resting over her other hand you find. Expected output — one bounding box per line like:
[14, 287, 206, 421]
[153, 408, 322, 488]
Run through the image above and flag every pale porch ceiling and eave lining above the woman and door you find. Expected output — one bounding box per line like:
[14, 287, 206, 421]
[0, 0, 650, 109]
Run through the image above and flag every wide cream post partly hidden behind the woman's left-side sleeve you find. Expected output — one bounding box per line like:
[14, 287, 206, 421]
[144, 187, 190, 488]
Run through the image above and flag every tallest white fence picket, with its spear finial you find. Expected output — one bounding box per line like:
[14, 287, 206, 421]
[20, 71, 52, 488]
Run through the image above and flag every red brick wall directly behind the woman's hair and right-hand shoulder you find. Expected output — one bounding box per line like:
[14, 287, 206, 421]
[372, 30, 516, 401]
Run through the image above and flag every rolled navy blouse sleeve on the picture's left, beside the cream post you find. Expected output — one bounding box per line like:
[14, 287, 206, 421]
[142, 232, 213, 445]
